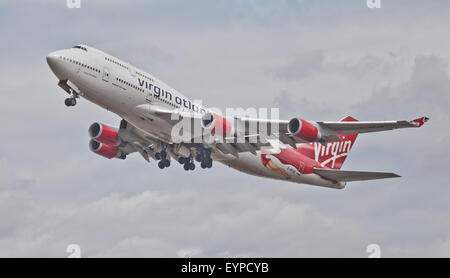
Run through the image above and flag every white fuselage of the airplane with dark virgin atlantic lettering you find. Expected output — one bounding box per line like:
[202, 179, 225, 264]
[47, 46, 343, 188]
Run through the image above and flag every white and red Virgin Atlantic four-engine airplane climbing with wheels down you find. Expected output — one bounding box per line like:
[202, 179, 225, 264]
[46, 44, 429, 189]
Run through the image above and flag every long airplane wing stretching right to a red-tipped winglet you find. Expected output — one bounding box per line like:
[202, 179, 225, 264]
[131, 101, 428, 157]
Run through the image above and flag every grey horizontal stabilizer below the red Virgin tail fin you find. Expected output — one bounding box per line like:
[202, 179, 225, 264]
[314, 169, 400, 182]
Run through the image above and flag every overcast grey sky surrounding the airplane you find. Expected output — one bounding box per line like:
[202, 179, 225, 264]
[0, 0, 450, 257]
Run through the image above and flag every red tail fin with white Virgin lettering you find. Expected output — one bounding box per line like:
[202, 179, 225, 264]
[297, 116, 358, 170]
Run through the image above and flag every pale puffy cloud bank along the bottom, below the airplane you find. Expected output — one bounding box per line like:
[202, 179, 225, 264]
[0, 182, 368, 256]
